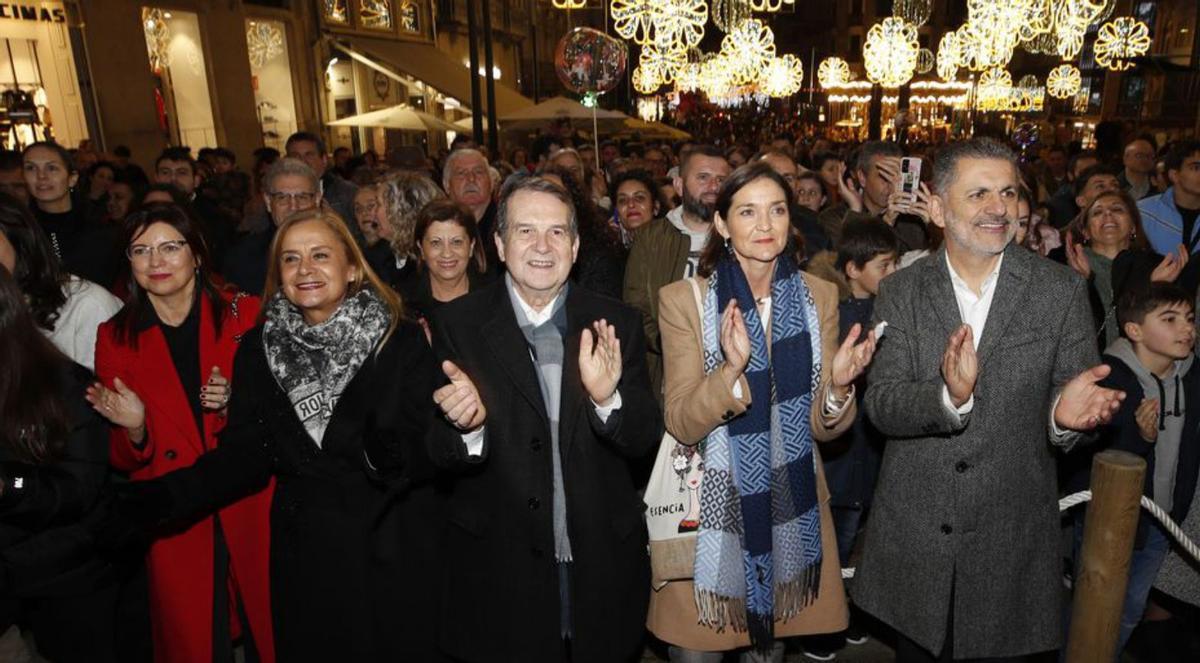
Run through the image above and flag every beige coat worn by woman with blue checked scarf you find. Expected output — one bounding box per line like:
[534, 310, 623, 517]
[647, 274, 857, 651]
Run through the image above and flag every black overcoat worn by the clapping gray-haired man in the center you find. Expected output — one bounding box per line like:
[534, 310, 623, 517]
[430, 281, 662, 663]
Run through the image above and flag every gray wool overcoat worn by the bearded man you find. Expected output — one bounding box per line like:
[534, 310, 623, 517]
[851, 245, 1099, 658]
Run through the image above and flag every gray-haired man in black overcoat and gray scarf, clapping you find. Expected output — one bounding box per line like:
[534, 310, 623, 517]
[430, 177, 662, 663]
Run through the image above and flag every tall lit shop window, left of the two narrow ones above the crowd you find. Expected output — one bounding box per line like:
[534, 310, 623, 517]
[142, 7, 217, 149]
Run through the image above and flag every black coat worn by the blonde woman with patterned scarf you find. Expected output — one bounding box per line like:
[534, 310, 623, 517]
[164, 322, 442, 663]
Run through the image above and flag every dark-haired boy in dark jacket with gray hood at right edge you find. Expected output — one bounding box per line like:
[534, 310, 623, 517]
[1069, 283, 1200, 652]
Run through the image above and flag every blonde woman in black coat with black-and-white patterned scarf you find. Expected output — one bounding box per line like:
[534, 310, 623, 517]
[112, 210, 442, 662]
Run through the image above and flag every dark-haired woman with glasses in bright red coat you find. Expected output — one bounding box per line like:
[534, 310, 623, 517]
[89, 204, 275, 663]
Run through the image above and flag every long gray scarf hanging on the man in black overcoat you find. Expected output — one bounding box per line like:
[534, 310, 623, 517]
[505, 276, 571, 562]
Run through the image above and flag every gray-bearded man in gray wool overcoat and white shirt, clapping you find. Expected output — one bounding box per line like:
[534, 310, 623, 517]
[852, 139, 1123, 662]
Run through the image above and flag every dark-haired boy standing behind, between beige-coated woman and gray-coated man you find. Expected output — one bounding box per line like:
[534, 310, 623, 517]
[803, 219, 900, 661]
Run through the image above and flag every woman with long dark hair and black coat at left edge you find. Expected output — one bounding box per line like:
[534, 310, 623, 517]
[0, 267, 116, 663]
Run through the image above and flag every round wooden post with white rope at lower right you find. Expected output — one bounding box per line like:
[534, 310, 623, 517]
[1067, 450, 1146, 663]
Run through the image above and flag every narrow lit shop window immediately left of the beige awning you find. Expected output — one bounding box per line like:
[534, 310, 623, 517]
[246, 19, 296, 151]
